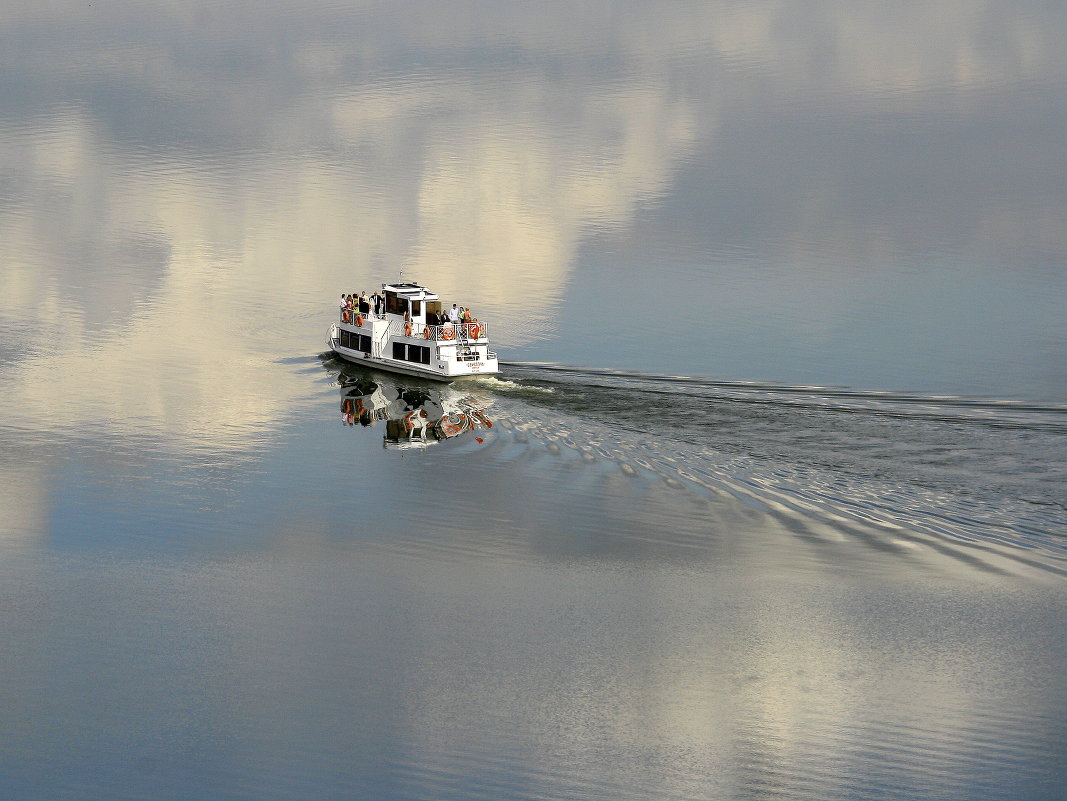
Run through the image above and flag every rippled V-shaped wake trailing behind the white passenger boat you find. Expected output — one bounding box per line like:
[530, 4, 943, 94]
[488, 363, 1067, 574]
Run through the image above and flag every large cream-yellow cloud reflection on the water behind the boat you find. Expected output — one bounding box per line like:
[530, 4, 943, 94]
[0, 0, 717, 447]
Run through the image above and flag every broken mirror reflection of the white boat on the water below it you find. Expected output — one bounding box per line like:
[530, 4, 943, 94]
[333, 363, 493, 449]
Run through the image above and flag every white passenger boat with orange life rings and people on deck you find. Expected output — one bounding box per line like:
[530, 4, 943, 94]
[327, 281, 499, 382]
